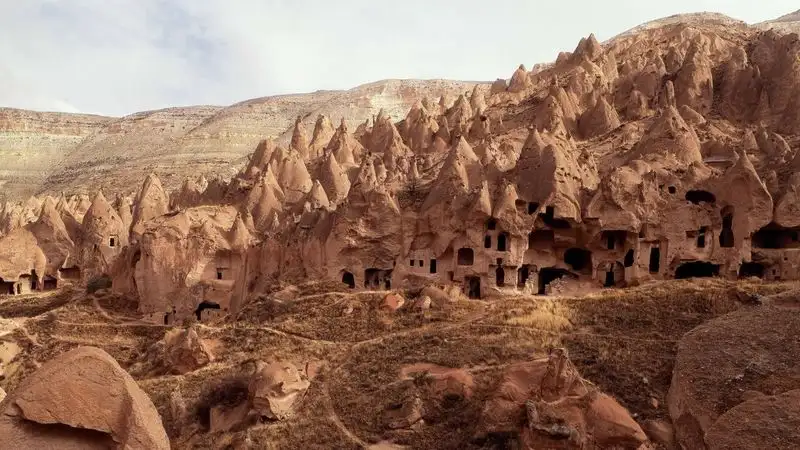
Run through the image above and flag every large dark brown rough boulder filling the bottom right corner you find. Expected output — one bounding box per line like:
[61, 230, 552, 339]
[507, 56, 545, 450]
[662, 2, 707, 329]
[667, 304, 800, 449]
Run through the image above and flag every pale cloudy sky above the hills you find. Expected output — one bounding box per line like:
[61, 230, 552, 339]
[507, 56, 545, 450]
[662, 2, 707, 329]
[0, 0, 800, 116]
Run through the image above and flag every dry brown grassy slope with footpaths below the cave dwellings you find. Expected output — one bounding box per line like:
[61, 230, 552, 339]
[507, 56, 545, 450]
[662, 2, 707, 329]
[0, 280, 796, 449]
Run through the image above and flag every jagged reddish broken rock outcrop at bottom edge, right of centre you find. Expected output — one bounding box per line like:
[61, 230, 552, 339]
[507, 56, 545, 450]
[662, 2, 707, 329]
[478, 349, 647, 449]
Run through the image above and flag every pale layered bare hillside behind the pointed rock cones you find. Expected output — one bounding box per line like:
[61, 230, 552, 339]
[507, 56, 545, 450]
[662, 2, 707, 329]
[0, 80, 474, 200]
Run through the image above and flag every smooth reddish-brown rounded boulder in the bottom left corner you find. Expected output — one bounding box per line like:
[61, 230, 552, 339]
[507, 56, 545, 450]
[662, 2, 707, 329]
[0, 347, 169, 450]
